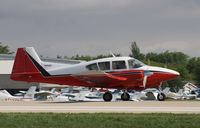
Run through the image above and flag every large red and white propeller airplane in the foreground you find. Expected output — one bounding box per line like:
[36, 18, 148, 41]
[11, 47, 180, 101]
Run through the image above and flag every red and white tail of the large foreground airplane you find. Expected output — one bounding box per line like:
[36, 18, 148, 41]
[10, 47, 50, 82]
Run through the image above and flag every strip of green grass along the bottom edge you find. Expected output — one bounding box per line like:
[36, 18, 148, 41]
[0, 113, 200, 128]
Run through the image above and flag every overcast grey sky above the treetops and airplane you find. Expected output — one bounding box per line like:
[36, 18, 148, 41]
[0, 0, 200, 57]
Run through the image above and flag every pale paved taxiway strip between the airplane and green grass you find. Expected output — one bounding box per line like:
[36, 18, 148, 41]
[0, 101, 200, 113]
